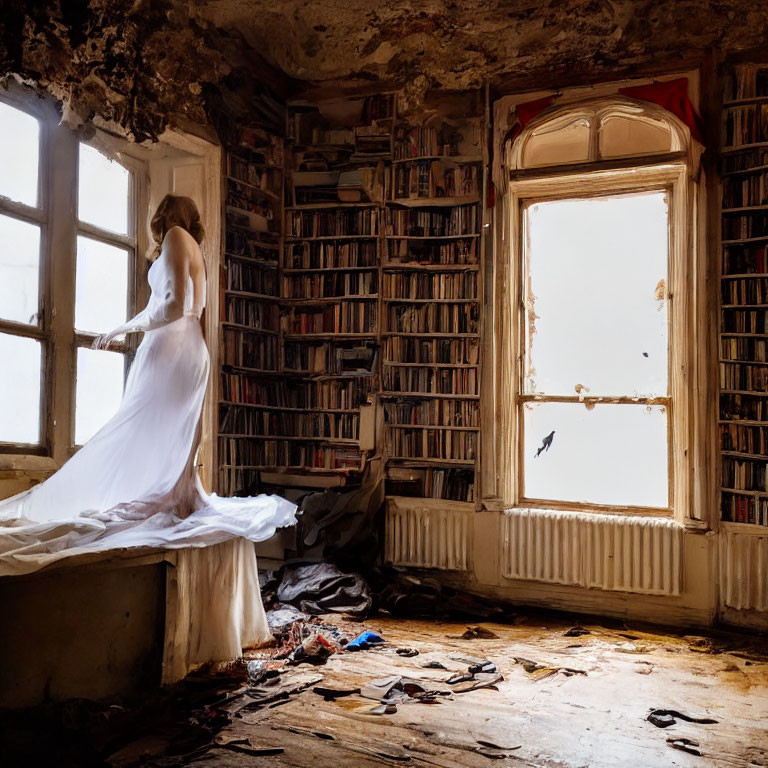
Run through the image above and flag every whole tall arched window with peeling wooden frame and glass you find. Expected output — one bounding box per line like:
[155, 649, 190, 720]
[498, 97, 698, 518]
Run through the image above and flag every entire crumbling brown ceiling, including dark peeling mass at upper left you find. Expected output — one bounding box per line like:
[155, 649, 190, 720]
[0, 0, 768, 140]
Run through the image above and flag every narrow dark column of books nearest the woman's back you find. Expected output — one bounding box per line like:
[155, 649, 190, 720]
[217, 129, 284, 496]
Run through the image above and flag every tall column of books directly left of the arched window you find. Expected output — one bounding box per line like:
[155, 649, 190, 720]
[381, 108, 483, 502]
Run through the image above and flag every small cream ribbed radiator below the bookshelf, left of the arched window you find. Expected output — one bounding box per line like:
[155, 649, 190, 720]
[385, 499, 472, 571]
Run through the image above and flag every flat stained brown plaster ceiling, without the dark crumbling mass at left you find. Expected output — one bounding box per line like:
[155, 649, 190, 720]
[194, 0, 768, 89]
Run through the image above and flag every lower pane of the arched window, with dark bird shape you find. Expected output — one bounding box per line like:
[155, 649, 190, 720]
[523, 403, 669, 508]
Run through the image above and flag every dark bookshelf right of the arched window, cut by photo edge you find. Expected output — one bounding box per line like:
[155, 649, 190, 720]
[719, 64, 768, 526]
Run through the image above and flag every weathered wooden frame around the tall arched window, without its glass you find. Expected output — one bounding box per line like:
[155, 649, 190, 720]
[481, 87, 717, 531]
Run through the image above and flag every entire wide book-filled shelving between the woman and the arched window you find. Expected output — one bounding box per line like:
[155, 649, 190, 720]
[218, 94, 485, 505]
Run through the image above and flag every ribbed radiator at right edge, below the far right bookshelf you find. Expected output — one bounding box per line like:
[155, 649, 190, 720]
[718, 530, 768, 611]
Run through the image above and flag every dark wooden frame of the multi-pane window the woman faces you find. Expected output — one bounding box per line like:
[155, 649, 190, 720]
[0, 87, 147, 464]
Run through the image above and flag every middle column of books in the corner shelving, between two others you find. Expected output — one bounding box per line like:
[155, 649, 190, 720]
[277, 95, 394, 484]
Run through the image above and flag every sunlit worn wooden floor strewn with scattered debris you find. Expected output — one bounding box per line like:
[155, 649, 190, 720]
[190, 617, 768, 768]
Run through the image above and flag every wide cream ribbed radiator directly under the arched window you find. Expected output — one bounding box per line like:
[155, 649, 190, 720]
[501, 509, 682, 595]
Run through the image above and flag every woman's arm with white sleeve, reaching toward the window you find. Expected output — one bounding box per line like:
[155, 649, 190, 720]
[92, 227, 189, 349]
